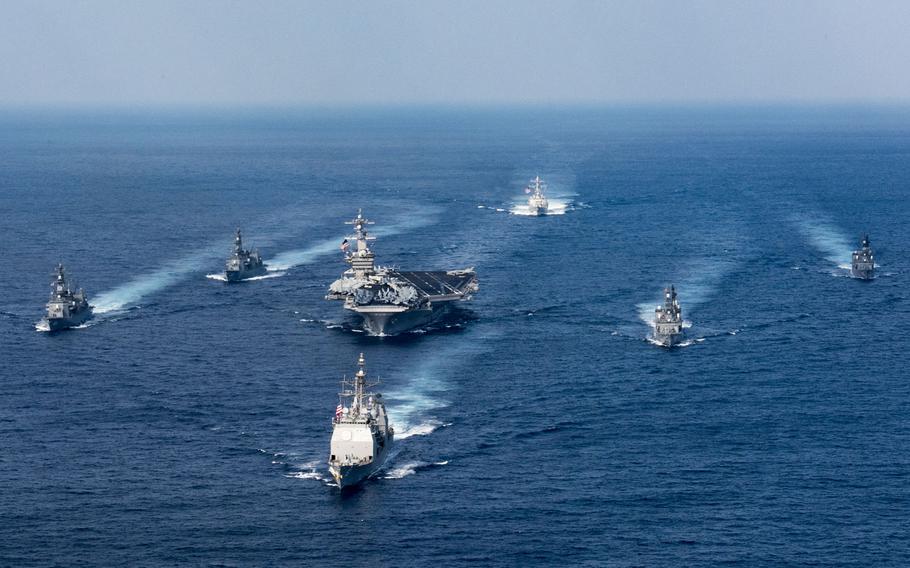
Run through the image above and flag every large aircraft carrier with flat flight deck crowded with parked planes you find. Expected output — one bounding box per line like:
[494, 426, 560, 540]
[326, 211, 478, 336]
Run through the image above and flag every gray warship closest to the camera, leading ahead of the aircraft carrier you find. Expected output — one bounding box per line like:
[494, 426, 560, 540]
[329, 353, 395, 489]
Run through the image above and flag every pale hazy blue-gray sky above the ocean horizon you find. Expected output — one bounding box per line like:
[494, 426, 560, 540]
[0, 0, 910, 105]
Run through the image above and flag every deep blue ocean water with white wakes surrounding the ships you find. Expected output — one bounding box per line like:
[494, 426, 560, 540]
[0, 107, 910, 566]
